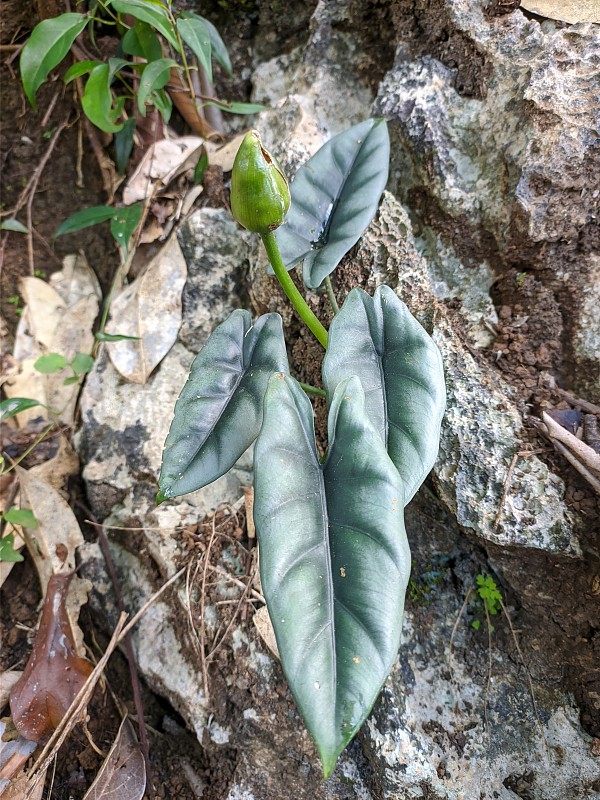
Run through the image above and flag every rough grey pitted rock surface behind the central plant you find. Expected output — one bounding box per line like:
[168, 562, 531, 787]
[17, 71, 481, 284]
[79, 0, 600, 800]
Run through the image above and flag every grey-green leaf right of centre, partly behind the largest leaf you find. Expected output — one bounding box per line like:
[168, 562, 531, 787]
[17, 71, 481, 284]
[323, 286, 446, 503]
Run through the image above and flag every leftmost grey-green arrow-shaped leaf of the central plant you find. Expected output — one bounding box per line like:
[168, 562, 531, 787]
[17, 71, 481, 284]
[159, 310, 288, 498]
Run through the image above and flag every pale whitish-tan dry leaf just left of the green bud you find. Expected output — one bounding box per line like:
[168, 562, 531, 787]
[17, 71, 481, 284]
[123, 136, 204, 206]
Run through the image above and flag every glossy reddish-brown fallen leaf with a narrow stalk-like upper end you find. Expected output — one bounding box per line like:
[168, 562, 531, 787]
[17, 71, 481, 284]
[10, 572, 93, 742]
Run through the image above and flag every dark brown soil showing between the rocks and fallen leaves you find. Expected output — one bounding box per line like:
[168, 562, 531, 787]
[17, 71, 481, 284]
[0, 0, 600, 800]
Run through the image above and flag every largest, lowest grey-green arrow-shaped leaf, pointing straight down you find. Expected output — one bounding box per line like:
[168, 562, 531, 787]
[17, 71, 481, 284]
[254, 375, 411, 777]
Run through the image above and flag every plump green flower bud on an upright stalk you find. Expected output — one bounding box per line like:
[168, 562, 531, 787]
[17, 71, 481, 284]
[231, 131, 290, 233]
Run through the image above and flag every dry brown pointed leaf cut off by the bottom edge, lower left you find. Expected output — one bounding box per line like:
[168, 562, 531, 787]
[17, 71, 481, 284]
[83, 717, 146, 800]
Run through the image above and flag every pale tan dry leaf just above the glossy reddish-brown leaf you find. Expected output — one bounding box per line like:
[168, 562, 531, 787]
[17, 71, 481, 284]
[15, 467, 92, 654]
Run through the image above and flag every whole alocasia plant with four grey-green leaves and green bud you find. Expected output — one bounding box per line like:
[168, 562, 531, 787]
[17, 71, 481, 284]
[158, 120, 445, 777]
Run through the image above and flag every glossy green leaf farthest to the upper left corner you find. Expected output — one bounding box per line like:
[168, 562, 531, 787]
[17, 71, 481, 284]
[20, 14, 88, 108]
